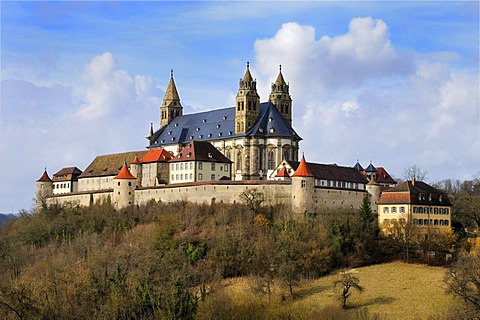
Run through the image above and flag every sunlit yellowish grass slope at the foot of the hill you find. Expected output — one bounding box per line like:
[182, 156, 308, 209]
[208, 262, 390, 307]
[219, 262, 454, 320]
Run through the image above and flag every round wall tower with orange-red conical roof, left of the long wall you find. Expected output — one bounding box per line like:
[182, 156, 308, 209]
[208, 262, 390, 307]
[113, 162, 137, 209]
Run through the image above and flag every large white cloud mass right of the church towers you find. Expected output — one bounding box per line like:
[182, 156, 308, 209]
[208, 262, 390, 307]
[254, 17, 480, 180]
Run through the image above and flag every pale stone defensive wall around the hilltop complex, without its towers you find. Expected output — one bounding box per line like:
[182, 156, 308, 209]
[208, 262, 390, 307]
[47, 180, 366, 212]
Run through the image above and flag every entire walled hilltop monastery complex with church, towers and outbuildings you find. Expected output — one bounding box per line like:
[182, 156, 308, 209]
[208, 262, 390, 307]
[36, 63, 451, 228]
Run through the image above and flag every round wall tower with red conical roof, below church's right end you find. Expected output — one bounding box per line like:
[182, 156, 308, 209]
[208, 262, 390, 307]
[292, 156, 315, 216]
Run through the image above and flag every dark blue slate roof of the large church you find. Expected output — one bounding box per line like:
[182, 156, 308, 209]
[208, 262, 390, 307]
[148, 102, 302, 148]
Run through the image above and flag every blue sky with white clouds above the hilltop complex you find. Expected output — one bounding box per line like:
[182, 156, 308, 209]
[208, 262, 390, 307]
[0, 1, 480, 213]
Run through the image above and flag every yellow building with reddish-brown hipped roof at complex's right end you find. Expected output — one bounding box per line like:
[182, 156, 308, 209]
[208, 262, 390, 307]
[378, 180, 452, 230]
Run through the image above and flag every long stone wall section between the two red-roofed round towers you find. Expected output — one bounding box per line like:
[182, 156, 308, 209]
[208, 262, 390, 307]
[135, 181, 291, 206]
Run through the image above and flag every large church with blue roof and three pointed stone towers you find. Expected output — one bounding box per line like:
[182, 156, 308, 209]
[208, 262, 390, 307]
[147, 63, 302, 180]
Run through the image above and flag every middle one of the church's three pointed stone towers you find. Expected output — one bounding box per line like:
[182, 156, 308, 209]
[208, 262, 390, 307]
[235, 62, 260, 134]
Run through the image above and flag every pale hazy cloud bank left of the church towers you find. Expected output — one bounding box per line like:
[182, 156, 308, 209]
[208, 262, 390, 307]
[0, 53, 163, 210]
